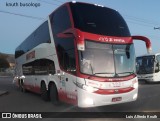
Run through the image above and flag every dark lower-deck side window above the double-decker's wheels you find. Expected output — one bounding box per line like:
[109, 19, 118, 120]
[22, 59, 55, 75]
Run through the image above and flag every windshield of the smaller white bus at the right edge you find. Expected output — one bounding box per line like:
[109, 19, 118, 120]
[136, 55, 155, 74]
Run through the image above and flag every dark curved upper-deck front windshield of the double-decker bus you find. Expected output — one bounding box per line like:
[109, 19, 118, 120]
[70, 3, 130, 37]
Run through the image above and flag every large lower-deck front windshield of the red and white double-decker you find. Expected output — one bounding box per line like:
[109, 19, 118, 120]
[79, 41, 135, 77]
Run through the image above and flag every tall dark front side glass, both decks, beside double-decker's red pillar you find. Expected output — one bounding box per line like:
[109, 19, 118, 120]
[51, 6, 76, 74]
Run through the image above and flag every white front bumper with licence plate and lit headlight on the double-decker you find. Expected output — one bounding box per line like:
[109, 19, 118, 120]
[78, 88, 138, 108]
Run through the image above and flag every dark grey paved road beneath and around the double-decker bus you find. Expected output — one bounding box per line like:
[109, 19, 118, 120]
[0, 77, 160, 121]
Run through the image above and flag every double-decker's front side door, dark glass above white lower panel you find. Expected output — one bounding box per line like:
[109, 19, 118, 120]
[58, 41, 77, 103]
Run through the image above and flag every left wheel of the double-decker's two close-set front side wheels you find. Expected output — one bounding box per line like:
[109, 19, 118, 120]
[41, 82, 49, 101]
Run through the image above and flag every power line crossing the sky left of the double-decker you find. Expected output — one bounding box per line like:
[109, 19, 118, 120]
[0, 10, 44, 20]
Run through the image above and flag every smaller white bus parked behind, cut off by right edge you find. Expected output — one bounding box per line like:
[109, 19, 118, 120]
[136, 53, 160, 83]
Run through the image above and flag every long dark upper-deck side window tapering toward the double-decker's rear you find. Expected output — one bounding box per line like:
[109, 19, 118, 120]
[15, 21, 50, 58]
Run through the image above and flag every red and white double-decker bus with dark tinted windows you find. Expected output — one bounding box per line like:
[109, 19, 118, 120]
[15, 2, 151, 107]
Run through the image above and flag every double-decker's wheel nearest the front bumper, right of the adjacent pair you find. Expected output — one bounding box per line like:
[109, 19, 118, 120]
[49, 83, 58, 105]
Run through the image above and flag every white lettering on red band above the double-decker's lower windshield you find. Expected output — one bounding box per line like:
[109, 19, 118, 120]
[98, 37, 125, 43]
